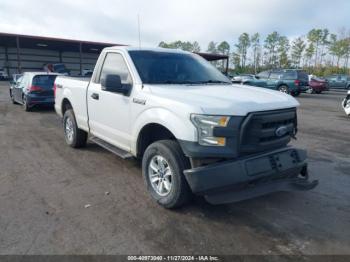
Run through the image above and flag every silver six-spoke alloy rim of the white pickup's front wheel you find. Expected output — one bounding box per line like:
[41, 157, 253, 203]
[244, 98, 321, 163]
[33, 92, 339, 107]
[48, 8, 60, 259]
[148, 155, 173, 196]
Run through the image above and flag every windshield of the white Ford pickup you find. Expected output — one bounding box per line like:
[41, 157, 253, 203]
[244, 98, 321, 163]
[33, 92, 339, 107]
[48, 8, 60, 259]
[129, 50, 231, 84]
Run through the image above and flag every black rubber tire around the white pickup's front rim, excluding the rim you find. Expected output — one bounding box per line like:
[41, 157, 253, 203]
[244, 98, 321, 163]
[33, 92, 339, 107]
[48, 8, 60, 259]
[142, 140, 192, 209]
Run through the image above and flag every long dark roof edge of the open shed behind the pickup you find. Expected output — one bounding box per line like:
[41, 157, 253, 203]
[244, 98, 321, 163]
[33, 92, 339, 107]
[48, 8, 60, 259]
[0, 33, 123, 53]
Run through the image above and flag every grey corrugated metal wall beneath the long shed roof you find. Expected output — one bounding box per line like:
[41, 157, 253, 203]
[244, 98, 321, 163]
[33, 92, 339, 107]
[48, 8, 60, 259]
[0, 46, 98, 76]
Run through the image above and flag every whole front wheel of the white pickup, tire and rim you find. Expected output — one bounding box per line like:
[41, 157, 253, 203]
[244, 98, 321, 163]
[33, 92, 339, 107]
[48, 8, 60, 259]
[142, 140, 191, 208]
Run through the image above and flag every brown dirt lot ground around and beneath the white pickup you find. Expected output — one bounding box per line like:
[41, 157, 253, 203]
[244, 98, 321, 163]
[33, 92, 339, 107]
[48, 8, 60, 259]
[0, 82, 350, 255]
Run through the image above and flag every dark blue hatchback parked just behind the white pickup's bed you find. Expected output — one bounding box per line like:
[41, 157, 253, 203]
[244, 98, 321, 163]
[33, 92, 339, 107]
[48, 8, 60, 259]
[10, 72, 59, 111]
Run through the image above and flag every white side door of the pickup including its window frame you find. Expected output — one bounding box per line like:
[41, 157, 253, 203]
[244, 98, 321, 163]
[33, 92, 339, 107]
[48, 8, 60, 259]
[87, 52, 132, 151]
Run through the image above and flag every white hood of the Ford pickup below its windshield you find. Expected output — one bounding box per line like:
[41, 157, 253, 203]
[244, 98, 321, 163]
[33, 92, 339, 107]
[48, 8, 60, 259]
[147, 84, 299, 116]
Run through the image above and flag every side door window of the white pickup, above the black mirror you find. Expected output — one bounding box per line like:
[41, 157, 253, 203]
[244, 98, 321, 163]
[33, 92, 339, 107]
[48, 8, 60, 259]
[98, 53, 132, 85]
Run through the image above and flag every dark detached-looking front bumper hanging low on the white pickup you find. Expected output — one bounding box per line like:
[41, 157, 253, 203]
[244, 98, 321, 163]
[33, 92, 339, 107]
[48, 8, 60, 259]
[184, 147, 318, 204]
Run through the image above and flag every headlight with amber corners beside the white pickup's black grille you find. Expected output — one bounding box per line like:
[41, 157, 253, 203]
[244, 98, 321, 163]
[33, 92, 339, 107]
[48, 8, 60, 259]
[191, 114, 230, 146]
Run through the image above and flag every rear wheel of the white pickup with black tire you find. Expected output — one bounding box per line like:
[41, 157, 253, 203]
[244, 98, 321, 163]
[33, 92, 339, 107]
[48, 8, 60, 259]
[63, 109, 87, 148]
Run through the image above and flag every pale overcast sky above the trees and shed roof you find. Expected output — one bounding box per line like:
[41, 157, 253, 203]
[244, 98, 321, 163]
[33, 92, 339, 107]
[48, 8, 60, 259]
[0, 0, 350, 50]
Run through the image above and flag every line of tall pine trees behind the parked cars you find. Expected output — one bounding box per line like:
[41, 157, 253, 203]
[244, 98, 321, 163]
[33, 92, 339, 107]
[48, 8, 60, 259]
[159, 28, 350, 76]
